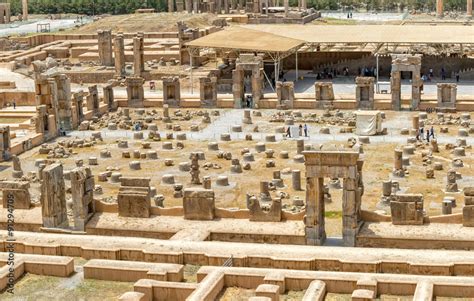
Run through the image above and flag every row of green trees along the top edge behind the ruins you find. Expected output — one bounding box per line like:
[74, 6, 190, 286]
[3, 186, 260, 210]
[3, 0, 467, 15]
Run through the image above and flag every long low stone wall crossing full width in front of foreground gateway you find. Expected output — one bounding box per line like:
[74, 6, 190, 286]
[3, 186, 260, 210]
[0, 234, 474, 276]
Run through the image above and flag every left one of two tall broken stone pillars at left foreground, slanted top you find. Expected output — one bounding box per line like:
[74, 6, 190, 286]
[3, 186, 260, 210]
[41, 163, 68, 228]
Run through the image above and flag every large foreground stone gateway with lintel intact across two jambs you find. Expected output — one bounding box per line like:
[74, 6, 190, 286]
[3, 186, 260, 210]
[303, 150, 364, 247]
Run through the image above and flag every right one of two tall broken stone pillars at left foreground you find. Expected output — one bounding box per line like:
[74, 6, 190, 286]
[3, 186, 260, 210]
[70, 167, 95, 231]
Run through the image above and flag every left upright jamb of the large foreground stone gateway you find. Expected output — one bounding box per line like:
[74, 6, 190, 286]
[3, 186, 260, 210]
[304, 178, 326, 245]
